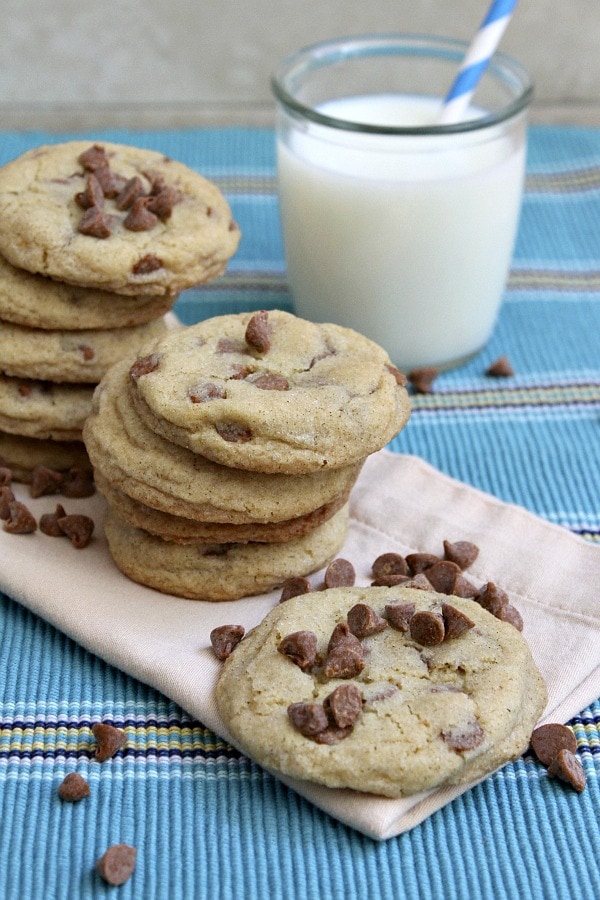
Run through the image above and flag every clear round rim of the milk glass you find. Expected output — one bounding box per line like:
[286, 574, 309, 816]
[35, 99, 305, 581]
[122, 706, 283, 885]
[271, 33, 533, 136]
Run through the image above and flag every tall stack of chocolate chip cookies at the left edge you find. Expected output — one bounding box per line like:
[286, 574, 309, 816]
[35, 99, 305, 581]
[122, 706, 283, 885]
[0, 141, 240, 481]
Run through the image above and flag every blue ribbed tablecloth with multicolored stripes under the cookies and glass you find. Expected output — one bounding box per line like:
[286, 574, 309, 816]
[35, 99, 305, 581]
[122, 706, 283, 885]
[0, 126, 600, 900]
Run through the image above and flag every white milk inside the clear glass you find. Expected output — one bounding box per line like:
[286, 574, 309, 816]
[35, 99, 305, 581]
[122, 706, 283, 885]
[277, 94, 525, 371]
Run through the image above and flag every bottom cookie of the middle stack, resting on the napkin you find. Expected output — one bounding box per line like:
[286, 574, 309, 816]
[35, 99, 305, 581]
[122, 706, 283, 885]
[104, 505, 348, 601]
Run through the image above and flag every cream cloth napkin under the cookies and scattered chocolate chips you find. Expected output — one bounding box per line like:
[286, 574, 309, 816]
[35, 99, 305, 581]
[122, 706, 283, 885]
[0, 450, 600, 839]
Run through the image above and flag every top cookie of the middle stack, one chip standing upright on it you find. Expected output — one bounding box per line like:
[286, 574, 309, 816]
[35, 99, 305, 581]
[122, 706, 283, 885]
[131, 310, 410, 475]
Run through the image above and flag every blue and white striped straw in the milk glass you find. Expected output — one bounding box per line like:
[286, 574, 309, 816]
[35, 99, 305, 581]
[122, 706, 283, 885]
[438, 0, 517, 125]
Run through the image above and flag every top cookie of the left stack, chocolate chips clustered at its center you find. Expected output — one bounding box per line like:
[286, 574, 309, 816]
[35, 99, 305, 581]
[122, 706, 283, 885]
[0, 141, 240, 295]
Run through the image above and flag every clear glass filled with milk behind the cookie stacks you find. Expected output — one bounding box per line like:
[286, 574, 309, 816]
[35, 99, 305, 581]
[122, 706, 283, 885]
[272, 35, 532, 371]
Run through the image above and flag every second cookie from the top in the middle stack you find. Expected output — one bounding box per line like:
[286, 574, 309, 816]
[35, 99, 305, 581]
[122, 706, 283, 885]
[84, 360, 362, 526]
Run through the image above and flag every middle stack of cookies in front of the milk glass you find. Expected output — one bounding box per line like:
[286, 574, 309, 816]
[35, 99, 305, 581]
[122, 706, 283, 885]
[83, 310, 410, 600]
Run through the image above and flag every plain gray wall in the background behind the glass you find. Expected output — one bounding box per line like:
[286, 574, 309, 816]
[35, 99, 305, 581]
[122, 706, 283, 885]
[0, 0, 600, 127]
